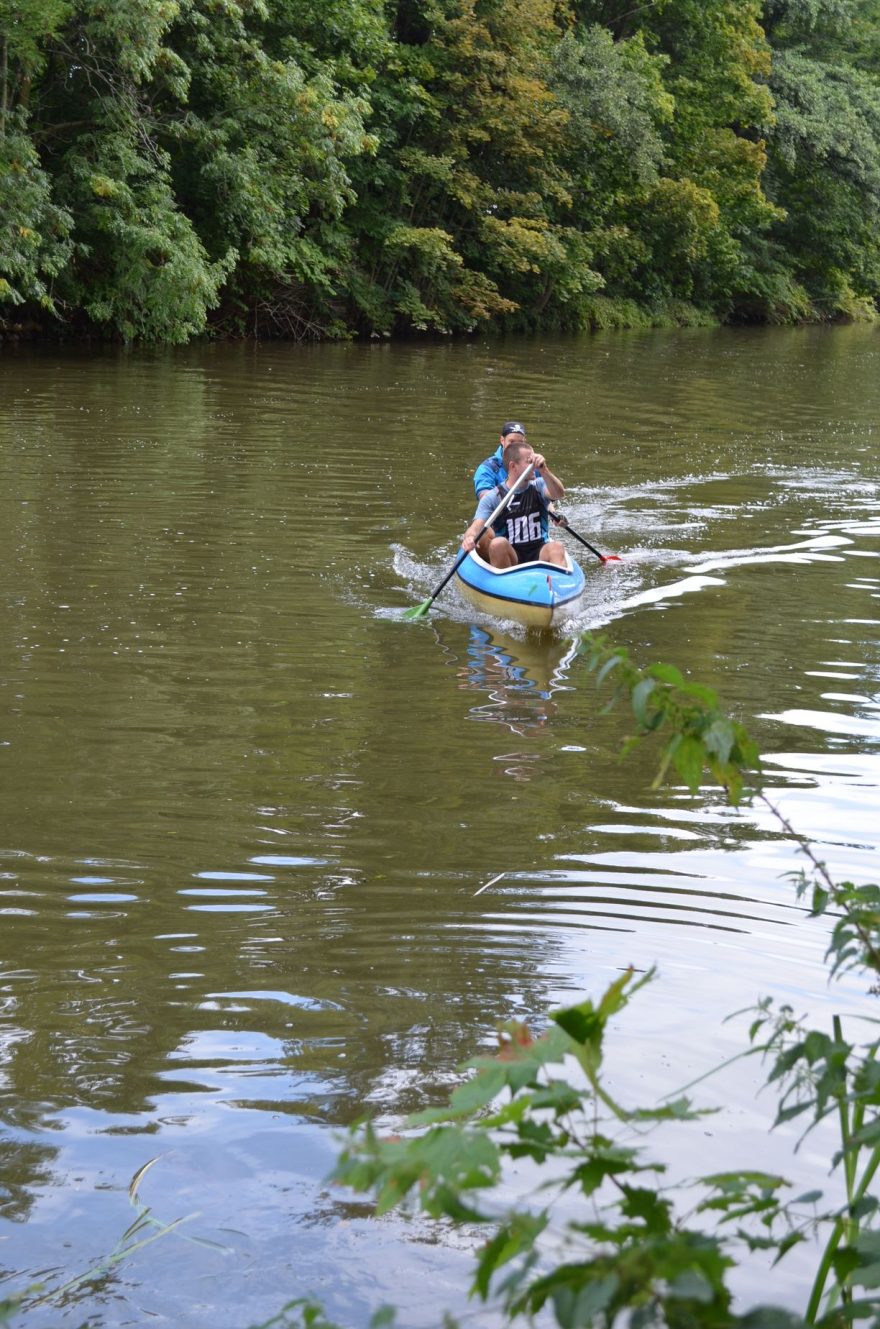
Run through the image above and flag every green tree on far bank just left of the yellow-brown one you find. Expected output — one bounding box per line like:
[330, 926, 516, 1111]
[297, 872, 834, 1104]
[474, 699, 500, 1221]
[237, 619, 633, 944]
[168, 0, 372, 329]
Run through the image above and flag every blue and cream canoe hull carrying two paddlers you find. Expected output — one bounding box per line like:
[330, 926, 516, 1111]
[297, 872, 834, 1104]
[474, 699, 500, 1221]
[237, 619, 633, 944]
[456, 550, 584, 627]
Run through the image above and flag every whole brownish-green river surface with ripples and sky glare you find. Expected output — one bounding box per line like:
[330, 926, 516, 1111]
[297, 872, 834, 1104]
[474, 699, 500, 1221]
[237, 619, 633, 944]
[0, 328, 880, 1329]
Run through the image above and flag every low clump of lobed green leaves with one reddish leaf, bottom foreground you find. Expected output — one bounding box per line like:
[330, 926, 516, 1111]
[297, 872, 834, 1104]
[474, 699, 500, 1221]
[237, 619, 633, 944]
[334, 971, 808, 1329]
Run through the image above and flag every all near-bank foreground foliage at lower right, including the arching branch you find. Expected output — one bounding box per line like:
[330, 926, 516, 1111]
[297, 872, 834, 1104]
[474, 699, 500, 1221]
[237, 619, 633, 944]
[319, 638, 880, 1329]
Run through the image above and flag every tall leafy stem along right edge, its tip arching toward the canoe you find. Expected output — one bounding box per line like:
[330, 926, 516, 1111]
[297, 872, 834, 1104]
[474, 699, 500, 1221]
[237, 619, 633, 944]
[581, 635, 880, 1324]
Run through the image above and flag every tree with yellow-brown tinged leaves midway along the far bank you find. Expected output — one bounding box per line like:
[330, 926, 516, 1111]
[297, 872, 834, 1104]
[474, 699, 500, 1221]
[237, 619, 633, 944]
[338, 0, 579, 331]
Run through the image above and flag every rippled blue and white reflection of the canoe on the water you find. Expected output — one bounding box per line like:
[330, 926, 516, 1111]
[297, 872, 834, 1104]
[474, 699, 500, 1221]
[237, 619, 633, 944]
[444, 625, 577, 780]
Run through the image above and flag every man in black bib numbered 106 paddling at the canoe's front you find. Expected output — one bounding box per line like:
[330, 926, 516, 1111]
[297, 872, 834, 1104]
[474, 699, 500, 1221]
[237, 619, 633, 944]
[461, 439, 566, 567]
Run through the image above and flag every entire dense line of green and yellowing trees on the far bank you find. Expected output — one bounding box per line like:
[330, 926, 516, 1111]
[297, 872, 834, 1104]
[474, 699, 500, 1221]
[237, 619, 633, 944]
[0, 0, 880, 343]
